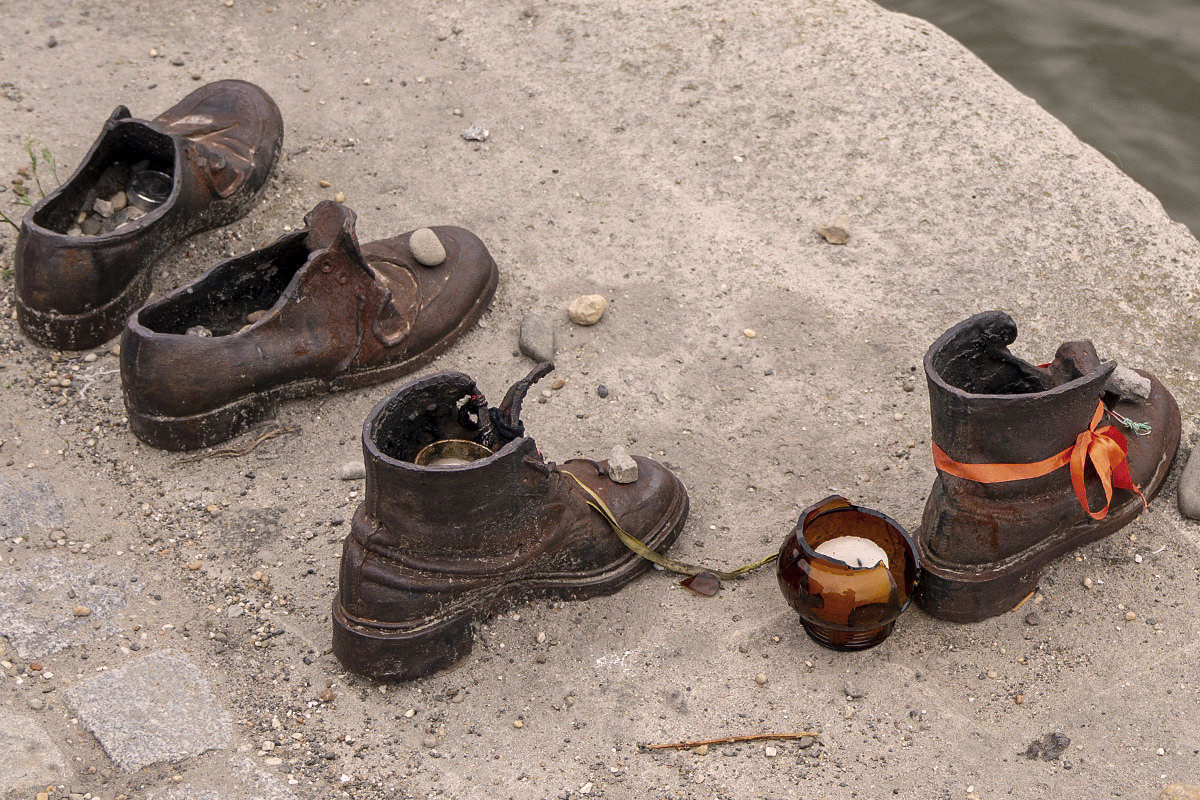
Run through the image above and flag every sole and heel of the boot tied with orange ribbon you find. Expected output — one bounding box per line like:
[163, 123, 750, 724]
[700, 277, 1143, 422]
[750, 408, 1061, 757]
[912, 395, 1180, 622]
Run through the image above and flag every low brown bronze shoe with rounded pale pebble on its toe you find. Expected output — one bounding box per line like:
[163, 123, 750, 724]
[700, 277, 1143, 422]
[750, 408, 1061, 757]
[121, 200, 499, 450]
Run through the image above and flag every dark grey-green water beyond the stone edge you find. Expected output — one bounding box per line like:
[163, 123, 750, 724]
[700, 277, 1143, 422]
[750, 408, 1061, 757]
[878, 0, 1200, 234]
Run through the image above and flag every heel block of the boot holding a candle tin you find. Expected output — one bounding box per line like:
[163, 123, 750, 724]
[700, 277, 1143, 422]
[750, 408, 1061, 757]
[334, 599, 474, 680]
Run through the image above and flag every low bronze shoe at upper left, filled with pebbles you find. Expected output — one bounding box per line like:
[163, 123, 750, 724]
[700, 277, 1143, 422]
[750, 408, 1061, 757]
[13, 80, 283, 350]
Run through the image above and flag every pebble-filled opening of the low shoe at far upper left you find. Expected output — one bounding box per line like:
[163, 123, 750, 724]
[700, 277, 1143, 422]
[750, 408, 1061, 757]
[34, 125, 175, 236]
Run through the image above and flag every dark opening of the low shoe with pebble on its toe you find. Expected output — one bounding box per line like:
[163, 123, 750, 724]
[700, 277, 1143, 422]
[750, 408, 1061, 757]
[138, 234, 308, 336]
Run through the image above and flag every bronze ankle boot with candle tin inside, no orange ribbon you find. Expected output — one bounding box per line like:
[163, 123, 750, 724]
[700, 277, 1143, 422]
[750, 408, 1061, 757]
[334, 365, 688, 679]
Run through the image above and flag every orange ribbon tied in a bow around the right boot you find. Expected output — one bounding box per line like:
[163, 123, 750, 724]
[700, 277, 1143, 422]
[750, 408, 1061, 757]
[934, 401, 1146, 519]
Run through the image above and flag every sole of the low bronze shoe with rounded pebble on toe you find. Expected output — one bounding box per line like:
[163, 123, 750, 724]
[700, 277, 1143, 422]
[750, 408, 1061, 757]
[125, 265, 500, 451]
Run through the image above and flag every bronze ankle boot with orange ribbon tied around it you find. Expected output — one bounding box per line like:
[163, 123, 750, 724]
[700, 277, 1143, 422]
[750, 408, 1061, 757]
[914, 311, 1180, 622]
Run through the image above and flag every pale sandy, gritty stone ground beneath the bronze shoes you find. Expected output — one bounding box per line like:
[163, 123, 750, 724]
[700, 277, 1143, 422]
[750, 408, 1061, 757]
[0, 0, 1200, 800]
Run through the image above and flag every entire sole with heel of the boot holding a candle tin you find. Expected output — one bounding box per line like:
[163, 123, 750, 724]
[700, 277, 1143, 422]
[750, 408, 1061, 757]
[334, 474, 689, 680]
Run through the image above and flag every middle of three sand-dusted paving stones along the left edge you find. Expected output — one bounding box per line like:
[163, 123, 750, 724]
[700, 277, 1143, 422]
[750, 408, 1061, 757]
[0, 555, 139, 658]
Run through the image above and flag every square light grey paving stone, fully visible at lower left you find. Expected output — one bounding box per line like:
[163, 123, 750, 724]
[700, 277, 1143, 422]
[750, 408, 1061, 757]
[67, 650, 229, 772]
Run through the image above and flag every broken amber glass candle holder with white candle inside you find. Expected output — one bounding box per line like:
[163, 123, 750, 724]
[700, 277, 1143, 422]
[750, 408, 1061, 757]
[778, 495, 920, 650]
